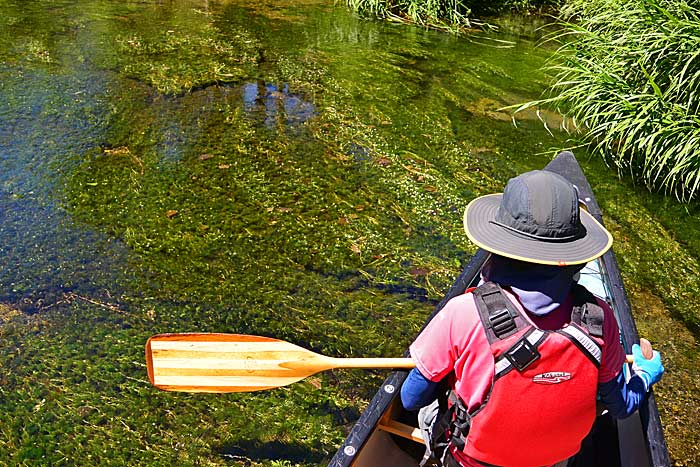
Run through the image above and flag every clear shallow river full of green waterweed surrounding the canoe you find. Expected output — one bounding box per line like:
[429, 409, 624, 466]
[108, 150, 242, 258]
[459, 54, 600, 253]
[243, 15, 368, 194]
[0, 0, 700, 466]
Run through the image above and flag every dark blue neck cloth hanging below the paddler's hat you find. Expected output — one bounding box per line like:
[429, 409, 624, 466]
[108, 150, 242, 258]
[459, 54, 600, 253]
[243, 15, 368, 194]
[481, 255, 585, 316]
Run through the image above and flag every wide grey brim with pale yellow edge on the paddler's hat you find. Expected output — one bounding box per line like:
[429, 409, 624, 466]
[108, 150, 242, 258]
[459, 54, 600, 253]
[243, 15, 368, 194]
[464, 193, 612, 266]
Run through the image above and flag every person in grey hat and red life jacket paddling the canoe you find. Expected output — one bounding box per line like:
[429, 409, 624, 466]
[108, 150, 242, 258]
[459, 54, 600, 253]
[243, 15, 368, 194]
[401, 170, 664, 467]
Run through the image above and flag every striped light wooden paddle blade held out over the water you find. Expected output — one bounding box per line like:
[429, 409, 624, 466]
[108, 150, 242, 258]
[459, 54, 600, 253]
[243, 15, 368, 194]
[146, 333, 332, 392]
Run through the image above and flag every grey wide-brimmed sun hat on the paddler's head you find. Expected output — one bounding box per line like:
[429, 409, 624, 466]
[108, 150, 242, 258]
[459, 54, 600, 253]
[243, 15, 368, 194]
[464, 170, 612, 266]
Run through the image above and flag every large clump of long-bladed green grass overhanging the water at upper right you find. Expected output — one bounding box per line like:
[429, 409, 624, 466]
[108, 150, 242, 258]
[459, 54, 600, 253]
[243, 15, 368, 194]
[518, 0, 700, 200]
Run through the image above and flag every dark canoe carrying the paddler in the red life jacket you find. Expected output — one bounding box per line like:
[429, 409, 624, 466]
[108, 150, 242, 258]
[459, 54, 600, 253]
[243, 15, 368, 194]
[328, 151, 671, 467]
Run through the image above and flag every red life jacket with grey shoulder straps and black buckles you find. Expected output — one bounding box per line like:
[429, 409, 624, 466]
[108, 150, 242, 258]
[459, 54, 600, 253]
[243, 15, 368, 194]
[429, 282, 604, 467]
